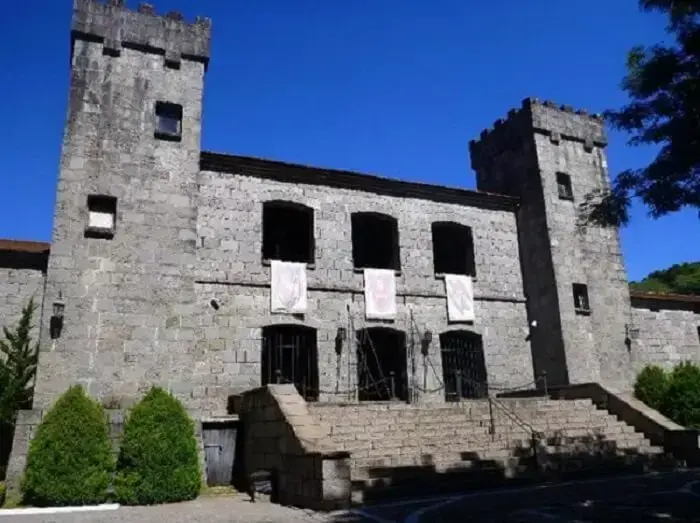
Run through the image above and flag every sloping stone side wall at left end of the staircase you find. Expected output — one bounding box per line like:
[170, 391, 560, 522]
[241, 385, 351, 510]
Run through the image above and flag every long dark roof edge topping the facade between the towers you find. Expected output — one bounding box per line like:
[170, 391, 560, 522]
[199, 151, 519, 211]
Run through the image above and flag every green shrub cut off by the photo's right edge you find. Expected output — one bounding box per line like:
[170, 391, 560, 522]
[661, 363, 700, 428]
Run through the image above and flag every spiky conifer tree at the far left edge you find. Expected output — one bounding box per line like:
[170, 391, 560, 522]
[0, 299, 39, 478]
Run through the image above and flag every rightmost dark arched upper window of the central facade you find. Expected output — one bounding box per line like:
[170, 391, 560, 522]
[431, 222, 476, 276]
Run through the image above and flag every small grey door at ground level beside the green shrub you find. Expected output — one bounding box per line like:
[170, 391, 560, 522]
[202, 420, 242, 487]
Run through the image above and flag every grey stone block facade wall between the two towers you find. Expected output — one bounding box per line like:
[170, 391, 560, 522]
[192, 168, 533, 413]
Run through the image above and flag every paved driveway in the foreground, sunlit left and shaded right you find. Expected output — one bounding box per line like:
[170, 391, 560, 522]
[0, 471, 700, 523]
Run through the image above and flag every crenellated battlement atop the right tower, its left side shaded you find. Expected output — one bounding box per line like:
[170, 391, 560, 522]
[469, 98, 608, 170]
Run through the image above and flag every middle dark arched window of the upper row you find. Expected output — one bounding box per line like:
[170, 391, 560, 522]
[351, 212, 401, 271]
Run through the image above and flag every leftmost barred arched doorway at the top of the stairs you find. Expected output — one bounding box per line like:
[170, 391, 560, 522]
[261, 325, 319, 401]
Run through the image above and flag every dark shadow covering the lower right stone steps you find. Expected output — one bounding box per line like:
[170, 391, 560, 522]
[332, 434, 674, 523]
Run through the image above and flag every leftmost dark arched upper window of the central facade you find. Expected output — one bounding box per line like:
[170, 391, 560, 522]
[262, 200, 315, 264]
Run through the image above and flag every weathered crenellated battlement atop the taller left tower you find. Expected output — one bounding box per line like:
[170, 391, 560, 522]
[71, 0, 211, 68]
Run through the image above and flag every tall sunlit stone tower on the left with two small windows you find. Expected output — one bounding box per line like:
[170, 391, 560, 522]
[34, 0, 211, 408]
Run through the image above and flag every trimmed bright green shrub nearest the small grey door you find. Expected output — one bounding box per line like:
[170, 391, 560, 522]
[115, 387, 201, 505]
